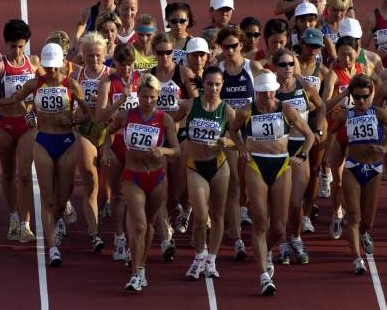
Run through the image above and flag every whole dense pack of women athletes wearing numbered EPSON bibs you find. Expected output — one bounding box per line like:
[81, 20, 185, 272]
[0, 0, 387, 295]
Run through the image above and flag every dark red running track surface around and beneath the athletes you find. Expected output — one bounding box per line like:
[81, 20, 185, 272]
[0, 0, 387, 310]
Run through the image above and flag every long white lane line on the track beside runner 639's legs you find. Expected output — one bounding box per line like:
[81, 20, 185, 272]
[32, 163, 49, 310]
